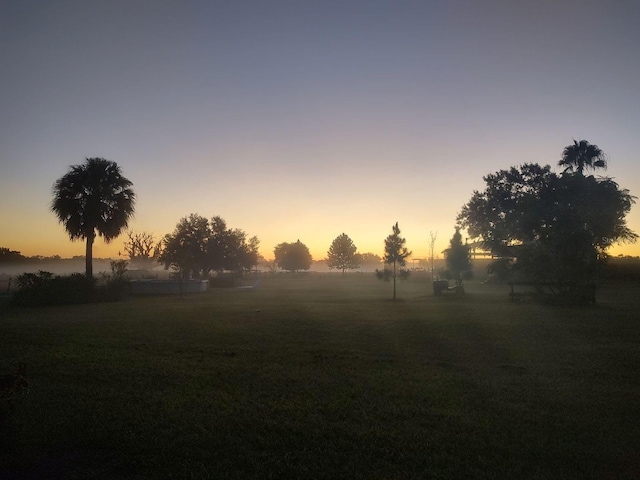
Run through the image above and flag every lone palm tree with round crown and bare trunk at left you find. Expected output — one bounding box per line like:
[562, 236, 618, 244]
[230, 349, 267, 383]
[51, 158, 136, 278]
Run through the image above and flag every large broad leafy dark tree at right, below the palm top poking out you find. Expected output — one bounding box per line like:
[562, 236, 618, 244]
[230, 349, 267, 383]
[458, 150, 638, 300]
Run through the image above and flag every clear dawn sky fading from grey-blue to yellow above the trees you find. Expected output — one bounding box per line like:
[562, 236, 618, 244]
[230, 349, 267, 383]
[0, 0, 640, 259]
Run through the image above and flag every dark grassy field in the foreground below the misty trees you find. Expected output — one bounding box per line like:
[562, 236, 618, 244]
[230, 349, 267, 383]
[0, 275, 640, 479]
